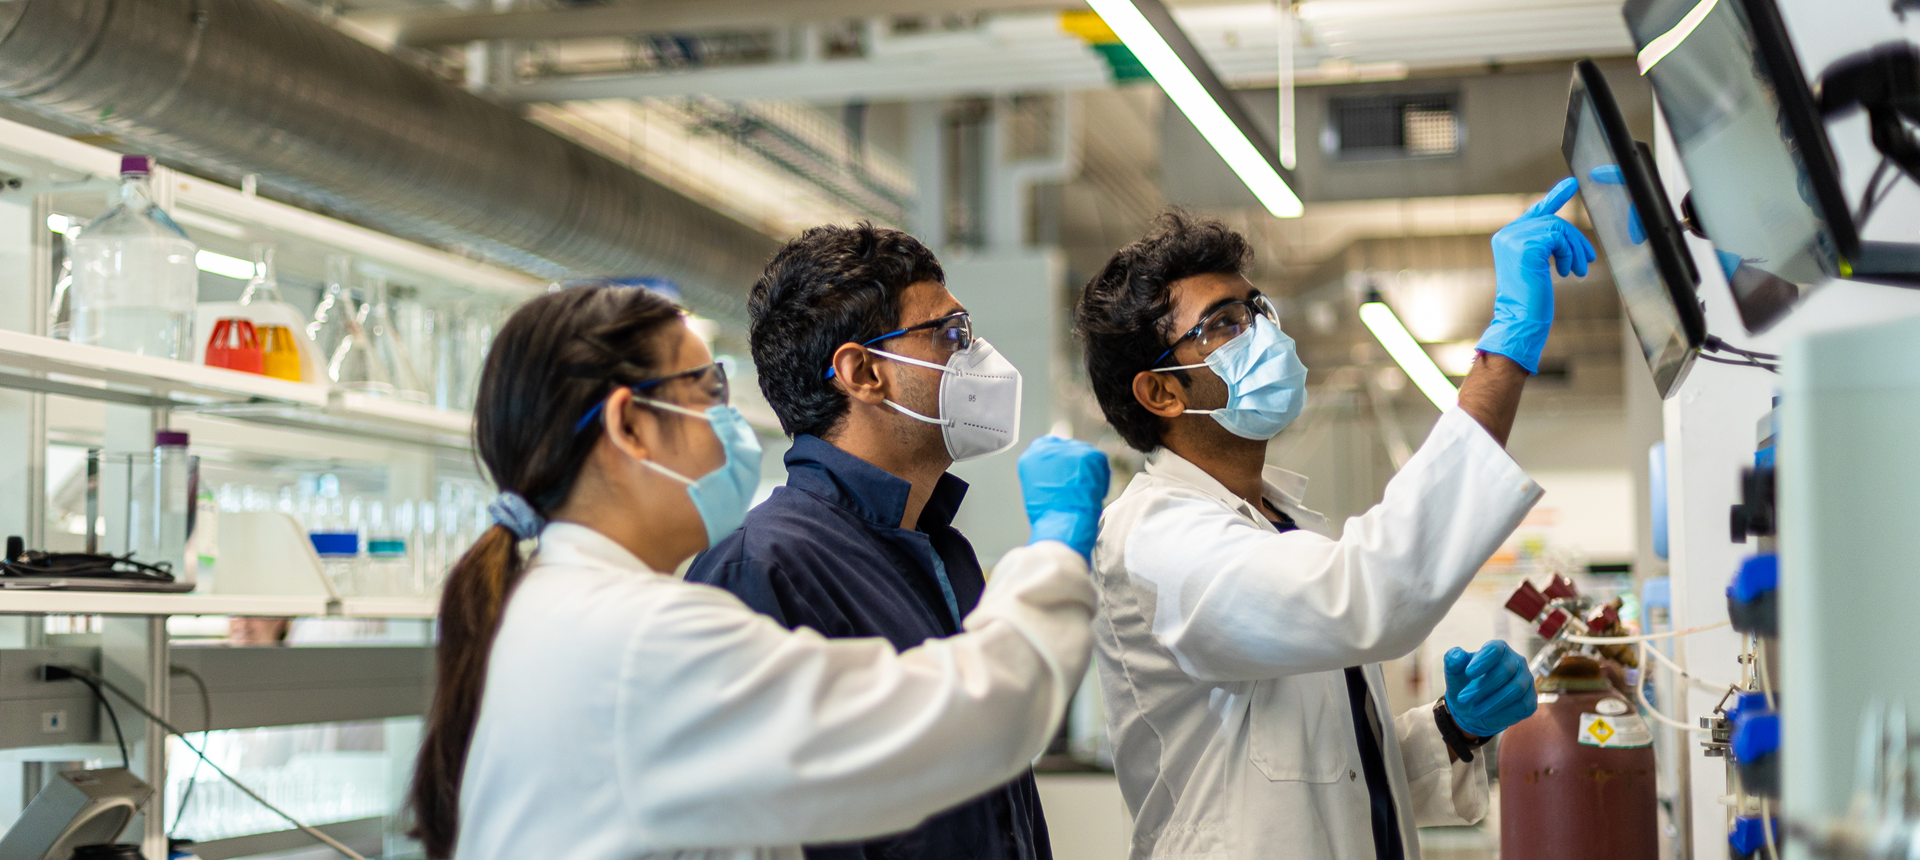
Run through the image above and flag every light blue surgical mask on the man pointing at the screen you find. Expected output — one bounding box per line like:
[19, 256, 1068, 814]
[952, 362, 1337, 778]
[1158, 315, 1308, 440]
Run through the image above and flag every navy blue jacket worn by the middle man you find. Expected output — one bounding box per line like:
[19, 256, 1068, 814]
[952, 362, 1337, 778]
[687, 434, 1052, 860]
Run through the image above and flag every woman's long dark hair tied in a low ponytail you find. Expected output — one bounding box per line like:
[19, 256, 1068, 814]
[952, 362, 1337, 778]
[409, 286, 680, 860]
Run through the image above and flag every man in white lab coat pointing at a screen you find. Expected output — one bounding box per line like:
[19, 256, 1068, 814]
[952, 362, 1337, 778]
[1075, 180, 1594, 860]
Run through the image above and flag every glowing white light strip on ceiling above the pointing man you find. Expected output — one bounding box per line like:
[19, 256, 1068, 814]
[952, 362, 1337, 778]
[1089, 0, 1306, 219]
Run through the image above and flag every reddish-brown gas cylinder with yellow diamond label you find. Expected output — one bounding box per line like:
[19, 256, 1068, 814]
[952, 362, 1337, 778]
[1500, 655, 1659, 860]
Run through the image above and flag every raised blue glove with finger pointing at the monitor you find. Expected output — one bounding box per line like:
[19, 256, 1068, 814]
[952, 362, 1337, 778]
[1478, 177, 1594, 372]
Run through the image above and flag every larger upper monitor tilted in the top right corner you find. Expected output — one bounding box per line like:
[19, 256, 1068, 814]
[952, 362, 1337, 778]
[1622, 0, 1860, 332]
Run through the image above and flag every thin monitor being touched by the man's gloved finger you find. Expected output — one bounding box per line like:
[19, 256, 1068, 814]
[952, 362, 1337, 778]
[1561, 60, 1707, 397]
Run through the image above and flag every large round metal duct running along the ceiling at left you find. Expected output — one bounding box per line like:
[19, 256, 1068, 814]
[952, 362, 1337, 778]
[0, 0, 776, 319]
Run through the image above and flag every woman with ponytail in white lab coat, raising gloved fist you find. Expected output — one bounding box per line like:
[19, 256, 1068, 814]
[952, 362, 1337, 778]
[411, 286, 1106, 860]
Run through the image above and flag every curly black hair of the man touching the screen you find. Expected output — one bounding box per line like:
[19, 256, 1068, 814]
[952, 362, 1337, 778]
[1073, 209, 1254, 451]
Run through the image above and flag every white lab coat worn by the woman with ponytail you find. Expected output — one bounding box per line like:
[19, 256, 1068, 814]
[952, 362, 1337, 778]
[457, 522, 1092, 860]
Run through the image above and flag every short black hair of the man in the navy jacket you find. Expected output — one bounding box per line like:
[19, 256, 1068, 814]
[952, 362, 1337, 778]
[747, 223, 947, 436]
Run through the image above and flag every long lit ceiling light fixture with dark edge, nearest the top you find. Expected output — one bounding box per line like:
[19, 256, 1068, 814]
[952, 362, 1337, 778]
[1089, 0, 1306, 219]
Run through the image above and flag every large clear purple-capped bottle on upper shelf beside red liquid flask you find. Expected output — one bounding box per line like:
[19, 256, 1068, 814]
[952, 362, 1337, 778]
[67, 155, 200, 361]
